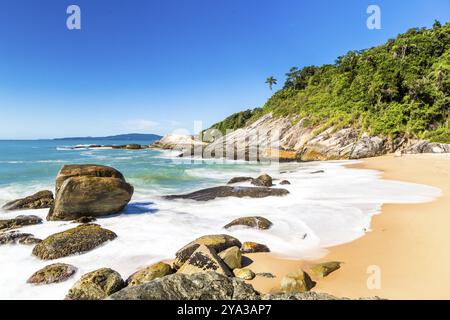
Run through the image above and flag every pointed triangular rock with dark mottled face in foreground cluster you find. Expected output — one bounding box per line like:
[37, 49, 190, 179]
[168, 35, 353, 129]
[177, 244, 231, 276]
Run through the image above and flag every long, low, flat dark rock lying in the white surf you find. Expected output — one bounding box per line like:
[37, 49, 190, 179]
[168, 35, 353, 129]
[165, 186, 289, 201]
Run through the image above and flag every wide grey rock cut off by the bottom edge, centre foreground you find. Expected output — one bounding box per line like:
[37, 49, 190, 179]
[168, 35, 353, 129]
[108, 272, 260, 300]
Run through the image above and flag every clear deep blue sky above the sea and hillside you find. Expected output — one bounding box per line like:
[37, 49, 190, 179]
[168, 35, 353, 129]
[0, 0, 450, 139]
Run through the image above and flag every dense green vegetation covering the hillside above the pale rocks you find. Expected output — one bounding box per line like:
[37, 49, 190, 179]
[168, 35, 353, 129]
[208, 22, 450, 143]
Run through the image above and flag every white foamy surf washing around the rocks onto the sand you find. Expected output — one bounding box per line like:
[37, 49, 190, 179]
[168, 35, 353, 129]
[0, 162, 440, 299]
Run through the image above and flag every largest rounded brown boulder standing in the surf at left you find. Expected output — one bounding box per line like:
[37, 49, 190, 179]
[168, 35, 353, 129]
[47, 165, 134, 221]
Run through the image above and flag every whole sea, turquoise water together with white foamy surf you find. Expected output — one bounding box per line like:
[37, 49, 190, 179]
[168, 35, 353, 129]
[0, 140, 440, 299]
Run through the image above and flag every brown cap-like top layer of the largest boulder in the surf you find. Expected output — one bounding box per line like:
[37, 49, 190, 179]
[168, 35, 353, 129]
[56, 164, 125, 195]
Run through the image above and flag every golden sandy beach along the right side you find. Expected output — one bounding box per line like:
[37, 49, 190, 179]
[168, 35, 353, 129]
[250, 154, 450, 299]
